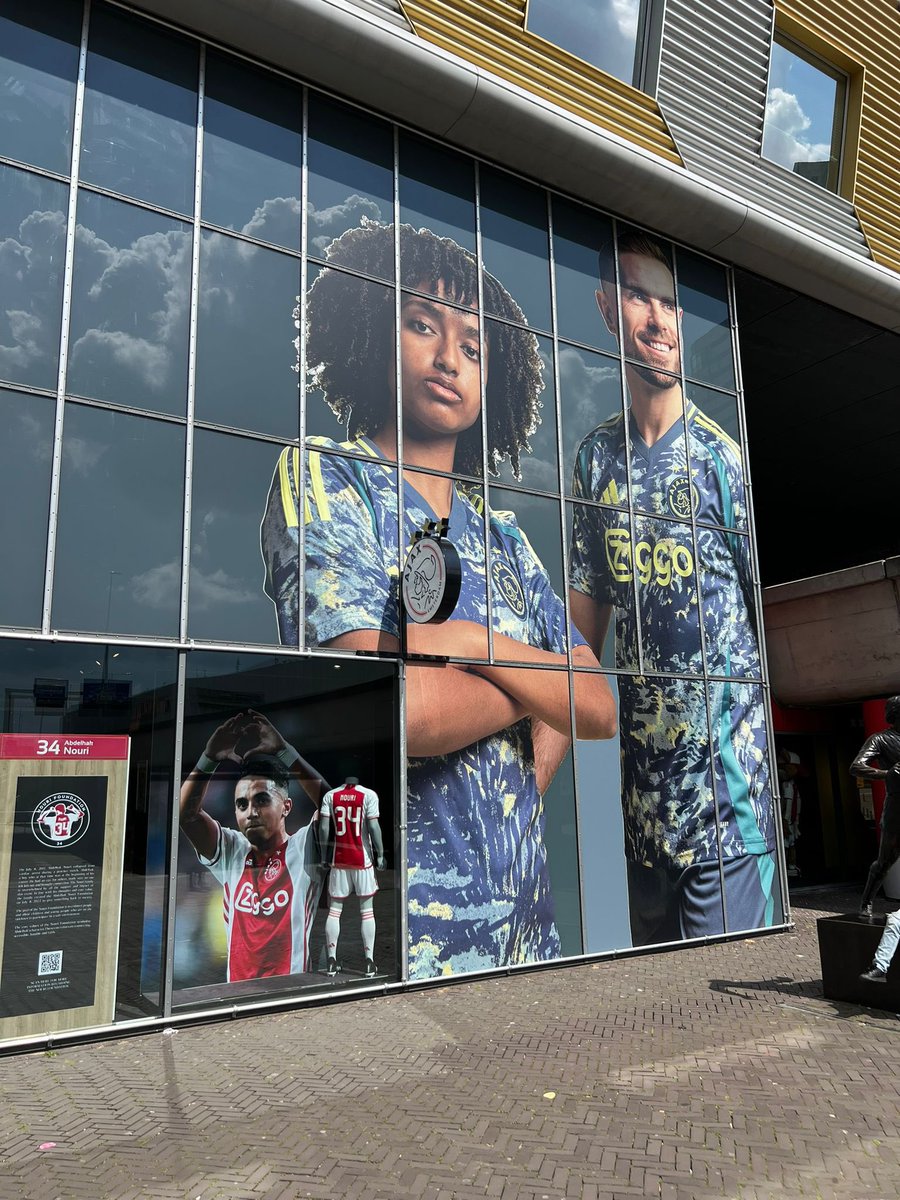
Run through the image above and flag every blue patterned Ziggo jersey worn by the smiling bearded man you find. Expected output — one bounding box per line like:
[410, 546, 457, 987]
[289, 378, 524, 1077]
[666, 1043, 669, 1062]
[570, 402, 775, 866]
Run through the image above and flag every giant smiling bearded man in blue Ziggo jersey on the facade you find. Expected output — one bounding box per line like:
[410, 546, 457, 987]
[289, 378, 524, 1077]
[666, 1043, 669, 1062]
[570, 229, 776, 946]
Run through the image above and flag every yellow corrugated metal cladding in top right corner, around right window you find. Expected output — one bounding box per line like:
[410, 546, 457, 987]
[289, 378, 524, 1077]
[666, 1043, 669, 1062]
[779, 0, 900, 270]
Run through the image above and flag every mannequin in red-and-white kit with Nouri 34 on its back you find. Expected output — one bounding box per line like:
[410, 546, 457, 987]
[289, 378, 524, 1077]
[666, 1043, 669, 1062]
[319, 775, 384, 976]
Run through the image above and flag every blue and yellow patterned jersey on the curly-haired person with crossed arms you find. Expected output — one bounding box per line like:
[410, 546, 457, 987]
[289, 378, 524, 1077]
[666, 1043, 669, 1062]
[262, 438, 583, 978]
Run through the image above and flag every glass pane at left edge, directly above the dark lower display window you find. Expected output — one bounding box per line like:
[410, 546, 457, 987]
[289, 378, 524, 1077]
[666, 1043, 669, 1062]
[0, 389, 56, 629]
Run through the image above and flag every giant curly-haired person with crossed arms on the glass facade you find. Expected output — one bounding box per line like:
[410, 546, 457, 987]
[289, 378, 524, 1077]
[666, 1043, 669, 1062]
[256, 222, 614, 978]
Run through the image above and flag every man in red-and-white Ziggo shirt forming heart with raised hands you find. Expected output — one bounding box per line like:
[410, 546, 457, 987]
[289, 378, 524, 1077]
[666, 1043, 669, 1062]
[180, 709, 328, 983]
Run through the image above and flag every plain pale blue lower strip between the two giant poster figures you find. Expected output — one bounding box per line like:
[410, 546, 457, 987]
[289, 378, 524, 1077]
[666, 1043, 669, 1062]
[575, 676, 631, 954]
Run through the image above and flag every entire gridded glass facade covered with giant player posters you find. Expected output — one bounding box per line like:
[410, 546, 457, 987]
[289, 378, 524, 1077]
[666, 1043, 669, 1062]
[0, 0, 784, 1040]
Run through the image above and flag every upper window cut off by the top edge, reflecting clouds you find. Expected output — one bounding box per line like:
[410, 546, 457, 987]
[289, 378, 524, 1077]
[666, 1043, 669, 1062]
[526, 0, 652, 88]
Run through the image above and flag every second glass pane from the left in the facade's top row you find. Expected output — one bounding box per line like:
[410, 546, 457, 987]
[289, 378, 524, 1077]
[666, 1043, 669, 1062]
[79, 5, 198, 212]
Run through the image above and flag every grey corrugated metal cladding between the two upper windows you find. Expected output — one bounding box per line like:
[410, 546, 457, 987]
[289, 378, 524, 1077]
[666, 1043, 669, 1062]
[659, 0, 873, 257]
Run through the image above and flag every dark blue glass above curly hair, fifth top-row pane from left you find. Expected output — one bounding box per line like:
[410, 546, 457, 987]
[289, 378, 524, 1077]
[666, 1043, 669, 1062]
[398, 130, 475, 254]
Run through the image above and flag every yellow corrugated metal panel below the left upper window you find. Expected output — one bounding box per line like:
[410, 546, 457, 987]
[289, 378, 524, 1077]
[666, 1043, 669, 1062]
[403, 0, 682, 164]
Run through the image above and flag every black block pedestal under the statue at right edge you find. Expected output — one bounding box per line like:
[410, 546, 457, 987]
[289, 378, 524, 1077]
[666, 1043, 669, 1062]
[816, 913, 900, 1013]
